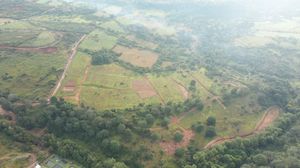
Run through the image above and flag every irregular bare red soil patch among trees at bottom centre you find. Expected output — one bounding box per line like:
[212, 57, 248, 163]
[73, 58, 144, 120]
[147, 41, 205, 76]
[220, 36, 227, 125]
[159, 129, 195, 155]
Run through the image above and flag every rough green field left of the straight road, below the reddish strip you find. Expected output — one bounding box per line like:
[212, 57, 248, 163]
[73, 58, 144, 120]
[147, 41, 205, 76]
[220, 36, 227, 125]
[0, 50, 66, 98]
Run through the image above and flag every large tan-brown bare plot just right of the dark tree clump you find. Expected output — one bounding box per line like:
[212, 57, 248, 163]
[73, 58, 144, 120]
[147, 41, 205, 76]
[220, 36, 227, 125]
[114, 45, 158, 68]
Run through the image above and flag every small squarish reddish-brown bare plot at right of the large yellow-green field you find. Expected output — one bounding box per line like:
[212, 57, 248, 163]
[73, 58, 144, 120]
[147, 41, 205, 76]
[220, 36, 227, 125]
[132, 79, 157, 99]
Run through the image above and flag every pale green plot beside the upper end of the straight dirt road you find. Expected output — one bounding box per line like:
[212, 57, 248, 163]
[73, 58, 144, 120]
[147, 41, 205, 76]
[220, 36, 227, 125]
[79, 30, 117, 51]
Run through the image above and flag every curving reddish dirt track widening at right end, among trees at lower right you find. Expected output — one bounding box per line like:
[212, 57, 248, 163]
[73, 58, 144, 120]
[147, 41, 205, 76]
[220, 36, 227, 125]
[204, 107, 280, 149]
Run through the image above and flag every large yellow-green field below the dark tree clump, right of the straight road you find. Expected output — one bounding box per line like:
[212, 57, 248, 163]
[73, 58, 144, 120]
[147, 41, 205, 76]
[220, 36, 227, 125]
[80, 64, 159, 109]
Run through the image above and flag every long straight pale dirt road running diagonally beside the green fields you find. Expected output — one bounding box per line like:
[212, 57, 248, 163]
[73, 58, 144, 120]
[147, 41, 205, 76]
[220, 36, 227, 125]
[48, 35, 86, 101]
